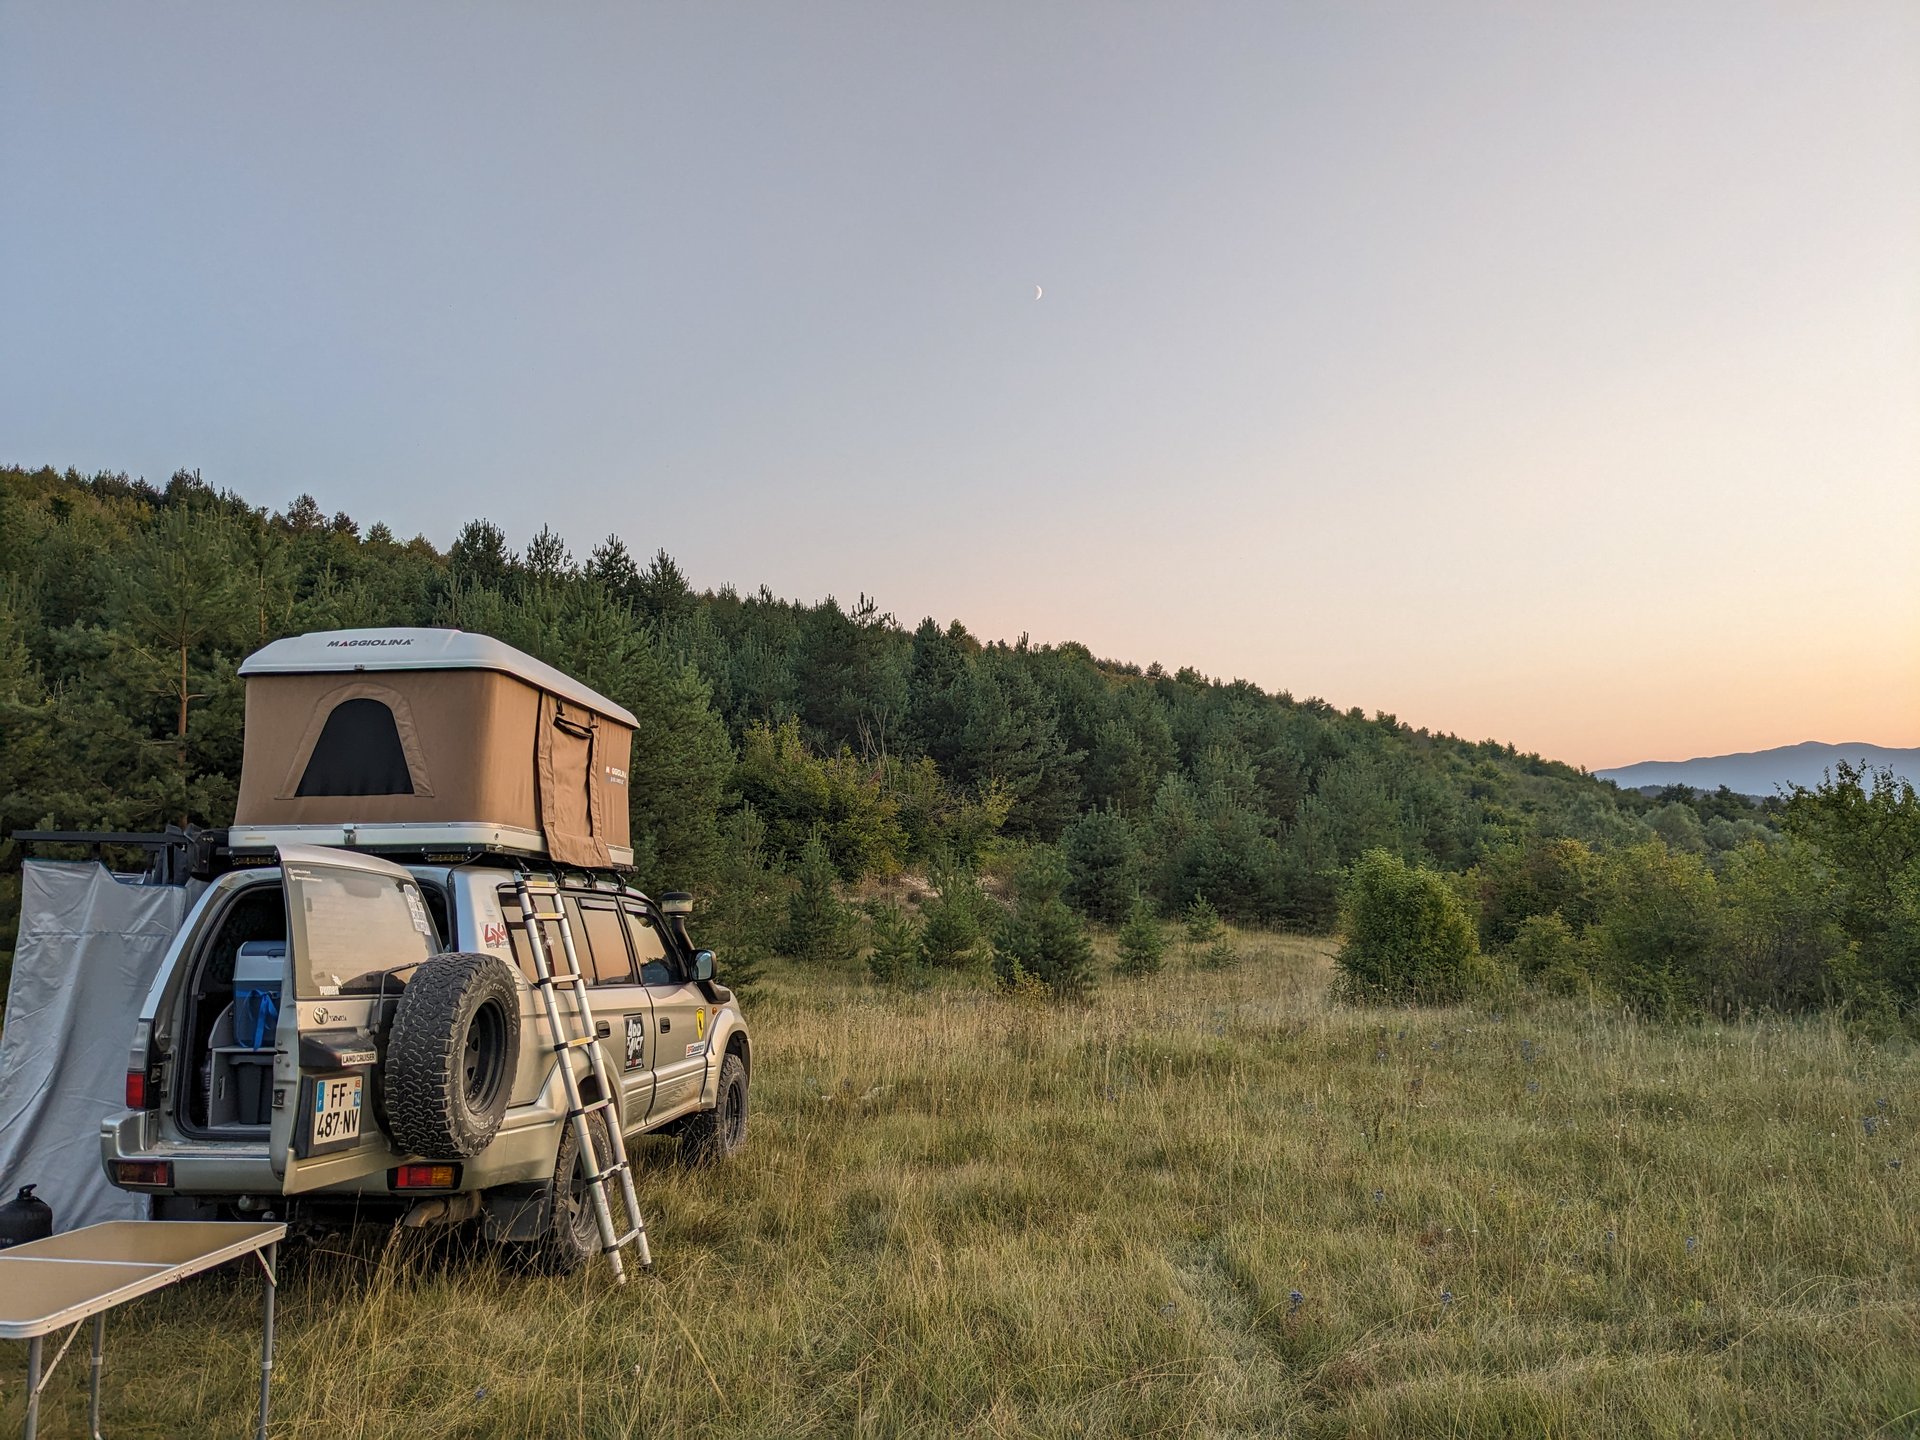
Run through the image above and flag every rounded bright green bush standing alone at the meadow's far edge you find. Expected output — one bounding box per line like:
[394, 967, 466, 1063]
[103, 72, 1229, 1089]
[1336, 851, 1486, 1000]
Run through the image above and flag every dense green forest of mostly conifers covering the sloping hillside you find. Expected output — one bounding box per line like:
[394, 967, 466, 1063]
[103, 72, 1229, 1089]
[0, 468, 1910, 1029]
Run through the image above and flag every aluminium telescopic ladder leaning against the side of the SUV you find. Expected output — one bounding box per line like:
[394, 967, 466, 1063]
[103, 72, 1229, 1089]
[513, 870, 653, 1284]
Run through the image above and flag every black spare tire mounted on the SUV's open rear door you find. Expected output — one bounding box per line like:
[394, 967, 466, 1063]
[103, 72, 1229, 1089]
[382, 954, 520, 1160]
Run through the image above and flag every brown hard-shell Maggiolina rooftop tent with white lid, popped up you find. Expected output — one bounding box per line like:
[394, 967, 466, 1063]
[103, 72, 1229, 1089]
[232, 628, 634, 866]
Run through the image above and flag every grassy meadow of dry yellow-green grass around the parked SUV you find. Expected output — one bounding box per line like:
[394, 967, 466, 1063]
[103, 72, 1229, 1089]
[0, 937, 1920, 1440]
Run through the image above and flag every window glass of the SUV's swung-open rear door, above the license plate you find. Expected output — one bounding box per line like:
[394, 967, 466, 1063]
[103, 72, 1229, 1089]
[286, 866, 440, 998]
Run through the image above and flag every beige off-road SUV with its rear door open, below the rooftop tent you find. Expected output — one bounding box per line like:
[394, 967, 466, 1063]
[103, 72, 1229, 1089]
[100, 845, 753, 1271]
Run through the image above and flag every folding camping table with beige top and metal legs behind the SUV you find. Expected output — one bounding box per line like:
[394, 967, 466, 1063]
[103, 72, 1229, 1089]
[0, 1219, 286, 1440]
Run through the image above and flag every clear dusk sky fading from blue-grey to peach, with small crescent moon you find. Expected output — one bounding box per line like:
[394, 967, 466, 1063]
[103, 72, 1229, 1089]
[0, 0, 1920, 768]
